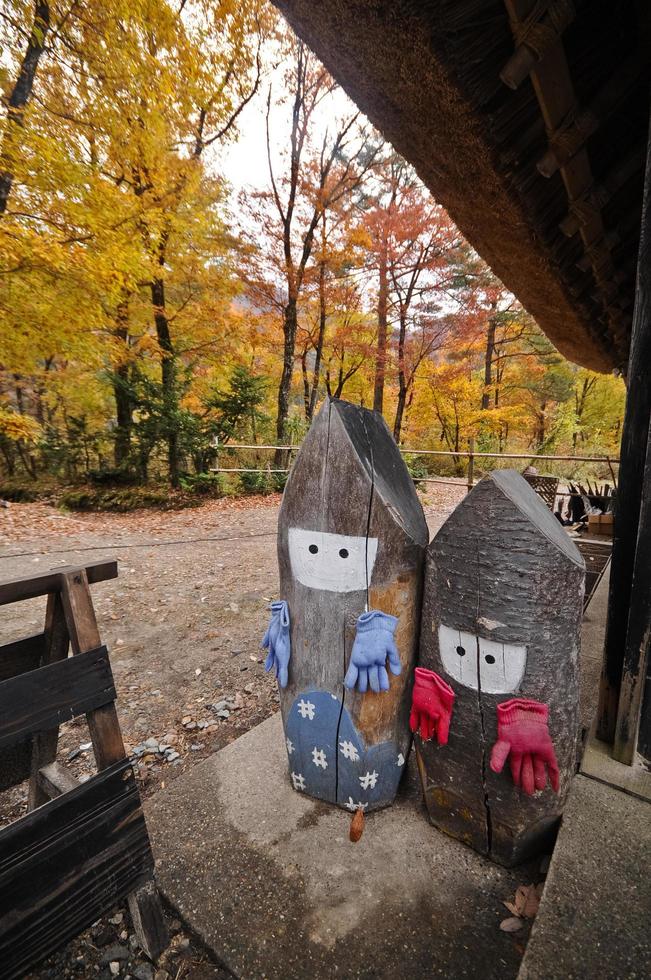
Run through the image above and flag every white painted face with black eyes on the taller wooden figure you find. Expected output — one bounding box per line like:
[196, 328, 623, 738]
[289, 527, 377, 592]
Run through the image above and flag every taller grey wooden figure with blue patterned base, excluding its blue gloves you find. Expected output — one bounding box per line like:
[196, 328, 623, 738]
[278, 400, 428, 810]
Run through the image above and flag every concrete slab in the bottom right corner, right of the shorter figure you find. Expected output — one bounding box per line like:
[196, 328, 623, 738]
[518, 776, 651, 980]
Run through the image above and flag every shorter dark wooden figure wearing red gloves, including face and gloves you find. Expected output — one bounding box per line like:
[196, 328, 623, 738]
[412, 470, 585, 865]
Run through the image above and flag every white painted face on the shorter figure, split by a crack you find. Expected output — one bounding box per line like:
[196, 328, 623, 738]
[439, 623, 527, 694]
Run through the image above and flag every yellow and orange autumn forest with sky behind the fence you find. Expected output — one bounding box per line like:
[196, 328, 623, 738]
[0, 0, 625, 508]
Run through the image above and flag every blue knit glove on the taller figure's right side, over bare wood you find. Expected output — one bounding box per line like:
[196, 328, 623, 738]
[344, 609, 402, 694]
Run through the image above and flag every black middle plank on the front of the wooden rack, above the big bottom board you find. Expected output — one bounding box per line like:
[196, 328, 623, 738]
[0, 647, 116, 746]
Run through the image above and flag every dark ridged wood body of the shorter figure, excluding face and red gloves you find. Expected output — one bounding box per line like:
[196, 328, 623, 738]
[416, 470, 585, 865]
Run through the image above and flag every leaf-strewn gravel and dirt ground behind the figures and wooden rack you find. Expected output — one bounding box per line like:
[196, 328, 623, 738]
[0, 481, 464, 980]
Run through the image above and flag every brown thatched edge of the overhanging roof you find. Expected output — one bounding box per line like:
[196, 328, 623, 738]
[274, 0, 648, 372]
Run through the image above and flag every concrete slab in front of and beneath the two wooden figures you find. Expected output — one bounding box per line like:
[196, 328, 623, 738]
[146, 715, 531, 980]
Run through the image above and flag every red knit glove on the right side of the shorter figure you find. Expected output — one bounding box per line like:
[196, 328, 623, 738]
[491, 698, 558, 796]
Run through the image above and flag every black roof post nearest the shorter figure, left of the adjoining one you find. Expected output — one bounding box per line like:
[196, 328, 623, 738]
[597, 113, 651, 742]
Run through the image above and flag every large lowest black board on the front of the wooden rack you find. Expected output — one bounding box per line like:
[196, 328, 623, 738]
[0, 759, 153, 980]
